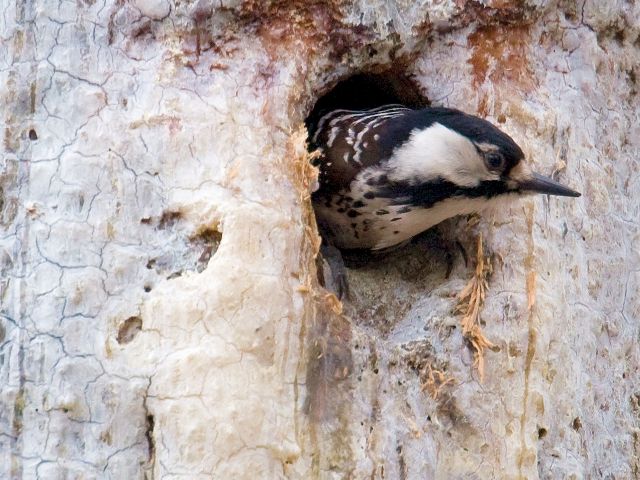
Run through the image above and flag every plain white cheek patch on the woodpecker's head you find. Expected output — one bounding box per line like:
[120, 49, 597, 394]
[388, 123, 500, 187]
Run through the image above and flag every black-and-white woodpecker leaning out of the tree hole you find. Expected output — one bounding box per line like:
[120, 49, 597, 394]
[309, 105, 580, 250]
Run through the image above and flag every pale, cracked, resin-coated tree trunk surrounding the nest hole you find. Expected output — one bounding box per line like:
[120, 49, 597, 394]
[0, 0, 640, 479]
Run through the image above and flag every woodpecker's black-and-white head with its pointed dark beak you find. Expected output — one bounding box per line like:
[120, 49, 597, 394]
[390, 108, 580, 198]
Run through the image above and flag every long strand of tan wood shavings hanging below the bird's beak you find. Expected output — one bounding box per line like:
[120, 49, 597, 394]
[456, 234, 494, 382]
